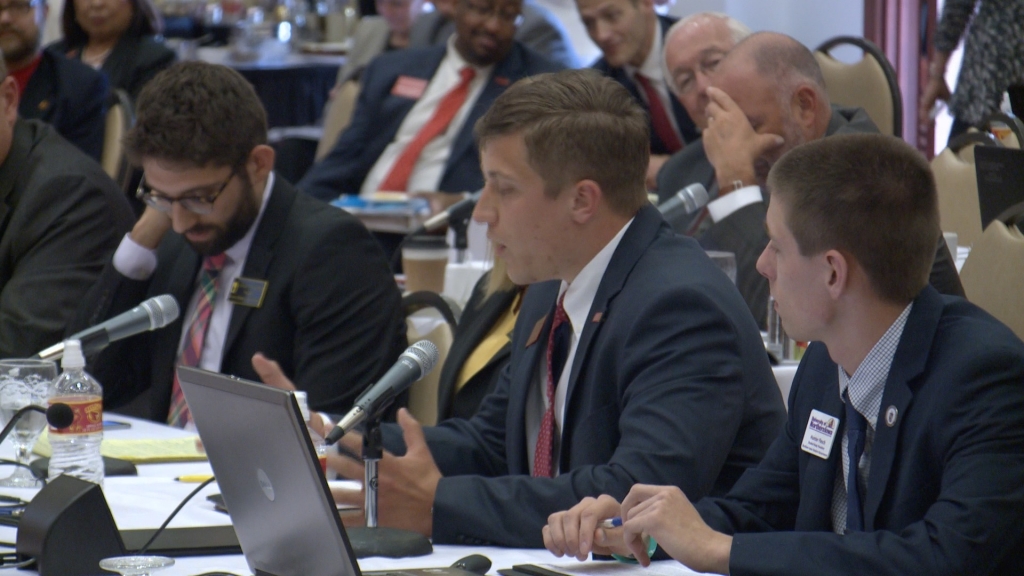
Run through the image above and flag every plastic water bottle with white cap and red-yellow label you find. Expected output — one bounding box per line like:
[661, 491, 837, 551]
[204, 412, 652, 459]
[49, 340, 103, 484]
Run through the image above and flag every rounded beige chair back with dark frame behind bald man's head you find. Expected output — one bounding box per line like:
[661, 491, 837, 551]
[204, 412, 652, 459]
[814, 36, 903, 136]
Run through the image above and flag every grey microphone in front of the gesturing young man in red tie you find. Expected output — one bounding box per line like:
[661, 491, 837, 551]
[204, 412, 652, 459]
[324, 340, 440, 446]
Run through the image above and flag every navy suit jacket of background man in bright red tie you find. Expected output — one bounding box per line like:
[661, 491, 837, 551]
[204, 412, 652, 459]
[298, 43, 558, 200]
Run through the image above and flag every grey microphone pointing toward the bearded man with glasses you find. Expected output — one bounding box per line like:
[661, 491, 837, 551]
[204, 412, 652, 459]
[36, 294, 180, 360]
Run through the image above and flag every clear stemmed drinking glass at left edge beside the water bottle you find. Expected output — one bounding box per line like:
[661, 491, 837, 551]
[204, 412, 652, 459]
[0, 359, 57, 488]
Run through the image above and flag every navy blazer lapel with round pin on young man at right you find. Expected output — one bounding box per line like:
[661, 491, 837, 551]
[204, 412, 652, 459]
[864, 286, 942, 531]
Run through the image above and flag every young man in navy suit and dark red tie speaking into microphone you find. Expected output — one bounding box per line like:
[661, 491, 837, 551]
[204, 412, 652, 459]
[292, 71, 785, 547]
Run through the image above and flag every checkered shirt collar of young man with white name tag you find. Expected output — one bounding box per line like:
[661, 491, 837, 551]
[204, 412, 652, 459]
[839, 302, 913, 429]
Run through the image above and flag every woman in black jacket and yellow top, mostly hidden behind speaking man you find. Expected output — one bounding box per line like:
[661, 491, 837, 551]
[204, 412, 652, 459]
[437, 257, 526, 422]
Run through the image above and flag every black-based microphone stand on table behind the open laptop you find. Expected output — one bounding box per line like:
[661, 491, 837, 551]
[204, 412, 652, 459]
[348, 416, 433, 558]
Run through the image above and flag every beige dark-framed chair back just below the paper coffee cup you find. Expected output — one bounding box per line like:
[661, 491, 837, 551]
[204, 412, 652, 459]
[401, 291, 461, 426]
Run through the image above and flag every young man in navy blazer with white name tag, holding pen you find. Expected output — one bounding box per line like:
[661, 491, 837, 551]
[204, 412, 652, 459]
[544, 134, 1024, 576]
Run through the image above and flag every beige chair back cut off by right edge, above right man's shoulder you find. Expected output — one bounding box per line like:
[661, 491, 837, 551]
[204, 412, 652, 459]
[961, 220, 1024, 338]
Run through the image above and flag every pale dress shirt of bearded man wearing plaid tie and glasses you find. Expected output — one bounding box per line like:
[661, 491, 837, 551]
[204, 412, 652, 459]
[114, 172, 274, 372]
